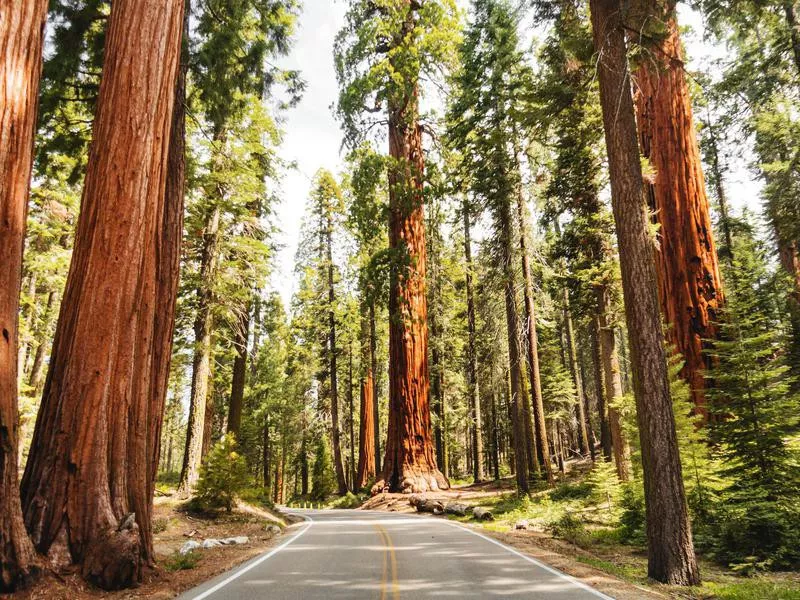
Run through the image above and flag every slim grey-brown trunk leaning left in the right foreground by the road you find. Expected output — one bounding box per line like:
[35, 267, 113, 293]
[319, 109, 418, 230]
[590, 0, 700, 585]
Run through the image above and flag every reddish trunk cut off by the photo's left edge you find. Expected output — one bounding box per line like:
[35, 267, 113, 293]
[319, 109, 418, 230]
[0, 0, 47, 592]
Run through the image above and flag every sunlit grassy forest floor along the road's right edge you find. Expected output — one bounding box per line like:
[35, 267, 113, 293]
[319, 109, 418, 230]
[354, 461, 800, 600]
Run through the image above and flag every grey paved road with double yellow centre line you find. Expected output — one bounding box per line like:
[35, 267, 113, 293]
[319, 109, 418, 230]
[179, 510, 608, 600]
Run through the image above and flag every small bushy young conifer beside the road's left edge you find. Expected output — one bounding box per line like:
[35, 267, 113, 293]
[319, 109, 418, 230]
[195, 433, 249, 512]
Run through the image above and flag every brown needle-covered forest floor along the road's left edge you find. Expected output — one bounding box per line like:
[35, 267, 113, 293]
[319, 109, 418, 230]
[9, 494, 300, 600]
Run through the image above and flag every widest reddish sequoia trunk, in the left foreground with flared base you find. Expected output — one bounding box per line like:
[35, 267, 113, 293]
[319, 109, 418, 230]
[22, 0, 183, 588]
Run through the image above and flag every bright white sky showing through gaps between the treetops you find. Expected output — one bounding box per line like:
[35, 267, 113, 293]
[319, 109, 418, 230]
[273, 0, 761, 307]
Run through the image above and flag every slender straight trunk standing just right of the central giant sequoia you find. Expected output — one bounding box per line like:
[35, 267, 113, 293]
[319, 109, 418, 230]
[463, 200, 484, 483]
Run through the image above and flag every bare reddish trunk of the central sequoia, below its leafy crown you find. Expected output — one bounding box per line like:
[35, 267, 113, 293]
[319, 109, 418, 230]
[373, 89, 450, 493]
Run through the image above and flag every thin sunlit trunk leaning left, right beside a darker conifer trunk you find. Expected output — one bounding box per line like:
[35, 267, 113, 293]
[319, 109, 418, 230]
[517, 185, 555, 485]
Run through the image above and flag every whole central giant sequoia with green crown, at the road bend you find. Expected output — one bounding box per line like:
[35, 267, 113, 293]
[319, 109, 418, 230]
[336, 0, 456, 491]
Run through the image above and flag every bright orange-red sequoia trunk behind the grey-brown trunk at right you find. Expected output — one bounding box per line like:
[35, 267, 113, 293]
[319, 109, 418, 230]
[632, 7, 723, 418]
